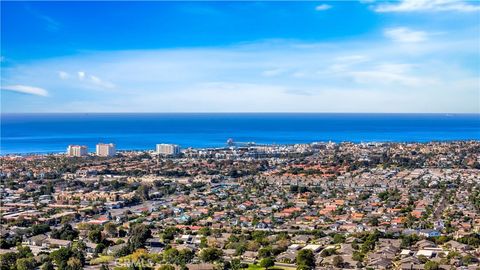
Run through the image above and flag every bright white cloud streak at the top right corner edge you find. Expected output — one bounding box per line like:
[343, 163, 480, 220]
[373, 0, 480, 12]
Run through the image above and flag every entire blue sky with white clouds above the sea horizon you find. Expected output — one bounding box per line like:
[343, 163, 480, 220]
[1, 0, 480, 113]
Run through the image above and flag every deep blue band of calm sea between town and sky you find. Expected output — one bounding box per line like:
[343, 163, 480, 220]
[0, 114, 480, 154]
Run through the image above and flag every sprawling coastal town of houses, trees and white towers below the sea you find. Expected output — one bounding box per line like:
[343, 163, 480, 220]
[0, 138, 480, 270]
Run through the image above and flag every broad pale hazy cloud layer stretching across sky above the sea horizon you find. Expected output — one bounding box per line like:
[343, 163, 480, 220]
[2, 35, 480, 112]
